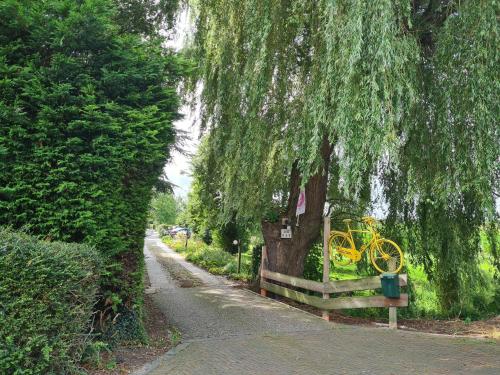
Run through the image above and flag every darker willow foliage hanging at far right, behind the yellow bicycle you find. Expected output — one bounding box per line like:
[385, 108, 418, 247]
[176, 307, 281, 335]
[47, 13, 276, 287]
[385, 1, 500, 313]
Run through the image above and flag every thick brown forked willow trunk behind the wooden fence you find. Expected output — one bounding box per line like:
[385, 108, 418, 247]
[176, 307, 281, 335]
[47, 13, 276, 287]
[261, 136, 332, 276]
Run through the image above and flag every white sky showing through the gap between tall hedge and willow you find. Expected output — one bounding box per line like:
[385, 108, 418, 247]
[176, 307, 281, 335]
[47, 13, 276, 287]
[164, 10, 196, 198]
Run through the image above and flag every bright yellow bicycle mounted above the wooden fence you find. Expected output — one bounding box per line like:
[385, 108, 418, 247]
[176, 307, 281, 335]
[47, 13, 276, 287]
[328, 216, 403, 273]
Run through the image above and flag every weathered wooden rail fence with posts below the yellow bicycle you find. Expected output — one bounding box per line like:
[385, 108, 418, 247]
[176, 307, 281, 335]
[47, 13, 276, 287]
[260, 217, 408, 328]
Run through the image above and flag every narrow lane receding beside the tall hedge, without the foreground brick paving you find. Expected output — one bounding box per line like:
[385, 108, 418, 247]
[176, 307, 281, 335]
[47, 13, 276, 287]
[145, 234, 333, 339]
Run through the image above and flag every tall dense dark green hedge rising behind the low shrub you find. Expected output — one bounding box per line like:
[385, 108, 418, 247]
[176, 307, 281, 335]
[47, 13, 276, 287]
[0, 0, 183, 326]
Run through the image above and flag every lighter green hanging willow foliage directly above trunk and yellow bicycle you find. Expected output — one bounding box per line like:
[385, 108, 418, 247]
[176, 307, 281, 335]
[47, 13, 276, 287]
[189, 0, 419, 219]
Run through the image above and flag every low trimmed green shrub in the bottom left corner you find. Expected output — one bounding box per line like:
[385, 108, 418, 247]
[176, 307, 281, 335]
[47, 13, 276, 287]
[0, 227, 100, 375]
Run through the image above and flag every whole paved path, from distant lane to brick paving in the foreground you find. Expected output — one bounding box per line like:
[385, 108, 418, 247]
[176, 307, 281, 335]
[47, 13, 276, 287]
[138, 235, 500, 375]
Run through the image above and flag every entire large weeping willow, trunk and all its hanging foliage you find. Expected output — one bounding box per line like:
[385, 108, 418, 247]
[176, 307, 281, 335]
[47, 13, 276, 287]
[192, 0, 499, 314]
